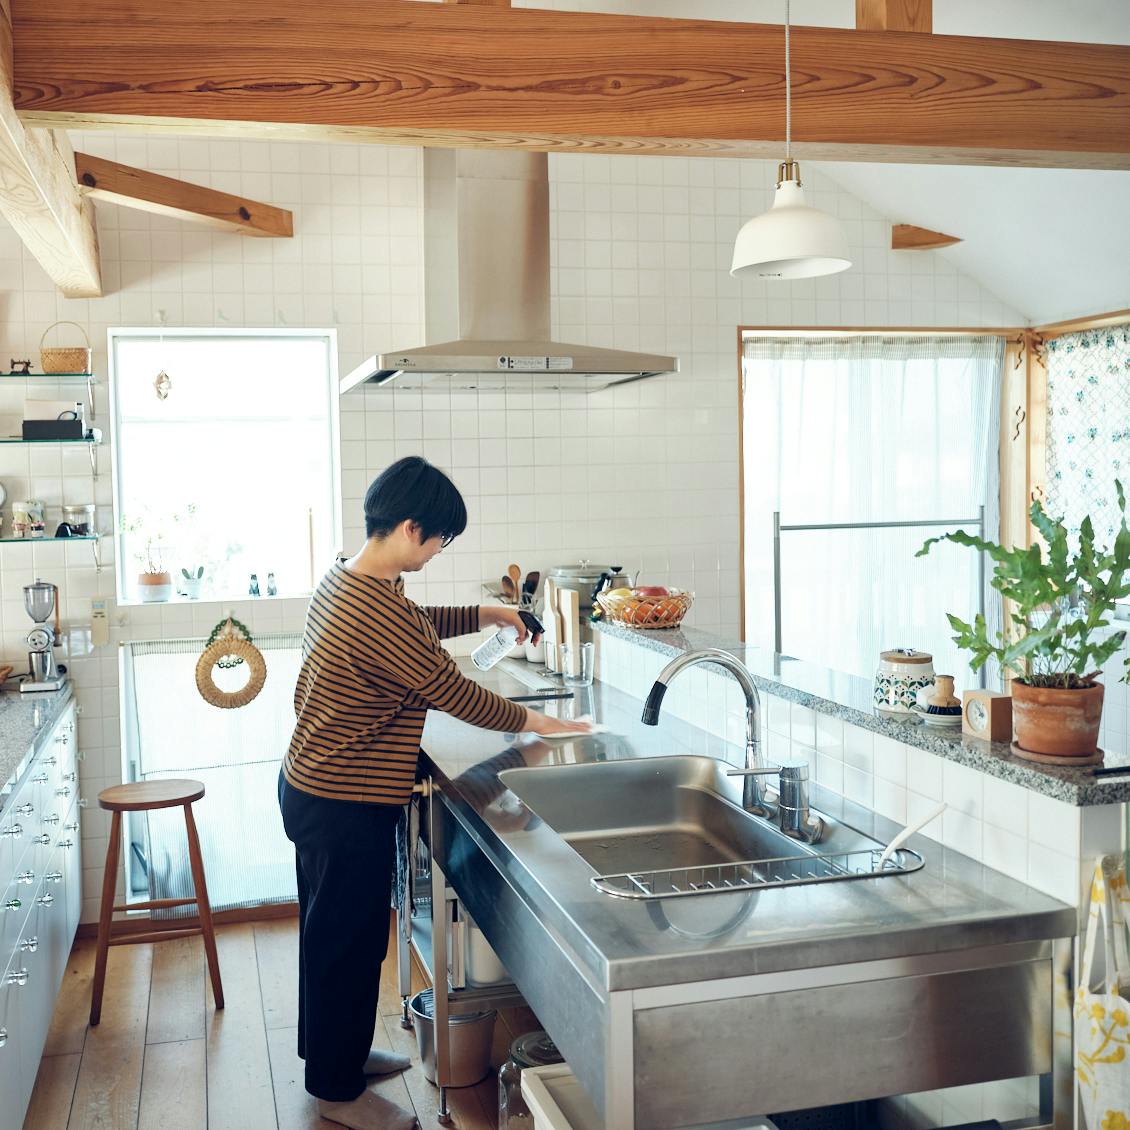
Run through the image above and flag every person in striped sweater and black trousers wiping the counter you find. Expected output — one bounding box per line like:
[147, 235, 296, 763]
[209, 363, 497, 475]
[279, 457, 592, 1130]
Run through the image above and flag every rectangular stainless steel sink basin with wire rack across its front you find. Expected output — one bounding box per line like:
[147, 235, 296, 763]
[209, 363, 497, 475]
[498, 756, 923, 898]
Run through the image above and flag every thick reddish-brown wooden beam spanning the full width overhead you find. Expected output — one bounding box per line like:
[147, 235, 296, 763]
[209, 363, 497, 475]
[12, 0, 1130, 168]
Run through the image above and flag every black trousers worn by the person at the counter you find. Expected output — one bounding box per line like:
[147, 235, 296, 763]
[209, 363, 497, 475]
[279, 773, 400, 1102]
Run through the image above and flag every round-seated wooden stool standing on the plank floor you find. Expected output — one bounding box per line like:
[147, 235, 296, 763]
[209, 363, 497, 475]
[90, 780, 224, 1025]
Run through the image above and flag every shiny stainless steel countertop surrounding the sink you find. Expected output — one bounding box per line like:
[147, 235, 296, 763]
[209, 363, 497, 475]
[423, 660, 1076, 993]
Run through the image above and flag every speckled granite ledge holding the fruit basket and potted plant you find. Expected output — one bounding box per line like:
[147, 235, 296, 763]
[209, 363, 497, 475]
[597, 623, 1130, 807]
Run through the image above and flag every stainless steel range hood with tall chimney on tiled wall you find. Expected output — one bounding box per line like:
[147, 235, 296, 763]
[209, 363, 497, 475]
[341, 149, 679, 392]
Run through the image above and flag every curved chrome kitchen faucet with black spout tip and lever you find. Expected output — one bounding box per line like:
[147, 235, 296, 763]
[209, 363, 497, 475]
[641, 647, 824, 843]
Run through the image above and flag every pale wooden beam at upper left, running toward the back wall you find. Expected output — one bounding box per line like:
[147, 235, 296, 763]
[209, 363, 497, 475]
[0, 0, 102, 298]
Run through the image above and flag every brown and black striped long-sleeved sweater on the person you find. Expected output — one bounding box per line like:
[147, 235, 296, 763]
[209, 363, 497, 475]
[283, 563, 525, 805]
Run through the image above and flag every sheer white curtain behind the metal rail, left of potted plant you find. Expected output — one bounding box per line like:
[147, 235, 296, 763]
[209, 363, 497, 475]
[742, 334, 1005, 687]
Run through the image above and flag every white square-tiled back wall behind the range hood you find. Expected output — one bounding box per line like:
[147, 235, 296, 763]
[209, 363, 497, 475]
[0, 133, 1016, 921]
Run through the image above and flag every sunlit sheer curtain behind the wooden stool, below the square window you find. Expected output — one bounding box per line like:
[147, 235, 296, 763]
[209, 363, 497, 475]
[121, 635, 302, 916]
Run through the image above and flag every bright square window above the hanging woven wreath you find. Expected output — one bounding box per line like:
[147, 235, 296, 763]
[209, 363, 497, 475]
[110, 330, 340, 603]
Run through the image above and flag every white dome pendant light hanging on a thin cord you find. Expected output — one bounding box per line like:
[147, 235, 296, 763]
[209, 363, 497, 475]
[730, 0, 851, 279]
